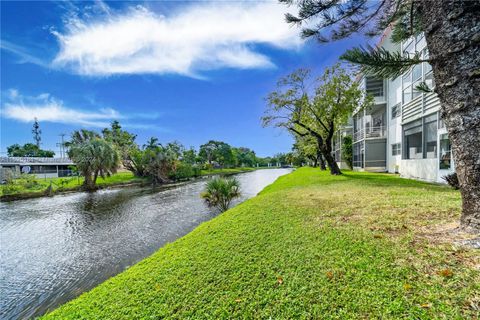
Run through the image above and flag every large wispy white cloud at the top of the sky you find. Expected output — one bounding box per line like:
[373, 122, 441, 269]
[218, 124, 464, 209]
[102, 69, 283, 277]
[54, 2, 302, 76]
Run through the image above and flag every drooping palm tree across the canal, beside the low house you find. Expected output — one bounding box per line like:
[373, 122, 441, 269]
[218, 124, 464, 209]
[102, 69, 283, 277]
[68, 131, 120, 191]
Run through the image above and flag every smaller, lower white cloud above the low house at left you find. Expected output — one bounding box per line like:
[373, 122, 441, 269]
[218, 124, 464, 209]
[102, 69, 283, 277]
[2, 89, 124, 128]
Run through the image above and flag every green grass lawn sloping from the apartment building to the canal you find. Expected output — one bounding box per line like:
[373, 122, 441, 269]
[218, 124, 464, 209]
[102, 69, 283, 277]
[46, 168, 480, 319]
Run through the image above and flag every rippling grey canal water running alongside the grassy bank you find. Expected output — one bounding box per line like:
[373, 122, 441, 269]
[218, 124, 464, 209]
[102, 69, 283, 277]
[0, 169, 290, 319]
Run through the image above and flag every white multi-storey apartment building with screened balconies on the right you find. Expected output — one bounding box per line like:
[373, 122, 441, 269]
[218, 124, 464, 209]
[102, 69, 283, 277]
[335, 30, 454, 182]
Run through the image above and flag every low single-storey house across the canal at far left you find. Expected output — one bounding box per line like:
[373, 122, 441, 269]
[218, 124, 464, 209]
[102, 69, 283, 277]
[0, 157, 74, 181]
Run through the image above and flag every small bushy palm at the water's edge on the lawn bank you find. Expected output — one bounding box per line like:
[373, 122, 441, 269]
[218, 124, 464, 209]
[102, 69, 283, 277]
[201, 177, 240, 212]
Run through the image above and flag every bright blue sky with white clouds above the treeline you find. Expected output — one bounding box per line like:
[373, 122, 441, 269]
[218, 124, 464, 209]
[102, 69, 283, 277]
[0, 1, 365, 156]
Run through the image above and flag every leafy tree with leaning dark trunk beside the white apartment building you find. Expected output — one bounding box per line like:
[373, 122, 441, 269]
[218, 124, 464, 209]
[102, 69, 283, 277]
[262, 65, 372, 175]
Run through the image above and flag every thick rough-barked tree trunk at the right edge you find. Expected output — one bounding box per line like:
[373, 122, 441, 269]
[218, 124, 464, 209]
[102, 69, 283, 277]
[416, 0, 480, 232]
